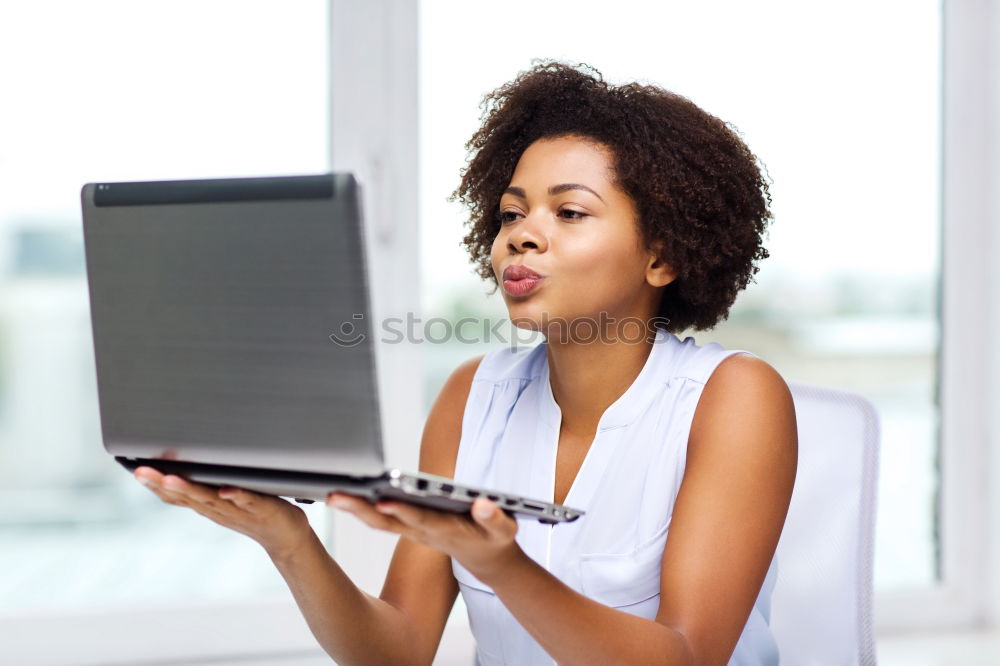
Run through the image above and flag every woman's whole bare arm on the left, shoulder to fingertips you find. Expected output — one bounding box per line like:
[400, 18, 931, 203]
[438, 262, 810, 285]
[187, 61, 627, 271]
[136, 357, 482, 666]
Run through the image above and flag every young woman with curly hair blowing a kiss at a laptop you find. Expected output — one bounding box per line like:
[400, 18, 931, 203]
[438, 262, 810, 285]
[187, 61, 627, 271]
[136, 62, 797, 666]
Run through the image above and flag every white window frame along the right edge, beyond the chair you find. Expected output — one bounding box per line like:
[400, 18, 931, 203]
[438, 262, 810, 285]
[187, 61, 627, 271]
[875, 0, 1000, 635]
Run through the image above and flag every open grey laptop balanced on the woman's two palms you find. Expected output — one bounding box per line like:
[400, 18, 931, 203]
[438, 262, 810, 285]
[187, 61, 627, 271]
[82, 173, 584, 524]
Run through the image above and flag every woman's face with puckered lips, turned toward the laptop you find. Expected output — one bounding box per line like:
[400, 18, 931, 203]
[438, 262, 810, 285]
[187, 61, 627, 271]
[491, 137, 674, 337]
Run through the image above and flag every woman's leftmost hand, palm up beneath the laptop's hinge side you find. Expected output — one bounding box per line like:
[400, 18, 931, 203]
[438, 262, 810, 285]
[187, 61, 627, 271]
[133, 467, 312, 557]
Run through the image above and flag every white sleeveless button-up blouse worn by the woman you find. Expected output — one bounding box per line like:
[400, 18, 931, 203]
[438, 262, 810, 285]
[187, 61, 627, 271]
[452, 329, 778, 666]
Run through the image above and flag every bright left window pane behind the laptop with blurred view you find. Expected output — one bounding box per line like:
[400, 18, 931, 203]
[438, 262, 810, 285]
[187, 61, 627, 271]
[0, 0, 330, 615]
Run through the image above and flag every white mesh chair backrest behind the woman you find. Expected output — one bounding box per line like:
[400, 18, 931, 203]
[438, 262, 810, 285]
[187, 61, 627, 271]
[770, 381, 880, 666]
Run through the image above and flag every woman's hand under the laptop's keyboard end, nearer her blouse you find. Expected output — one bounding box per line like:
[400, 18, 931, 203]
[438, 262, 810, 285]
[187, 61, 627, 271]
[326, 492, 523, 582]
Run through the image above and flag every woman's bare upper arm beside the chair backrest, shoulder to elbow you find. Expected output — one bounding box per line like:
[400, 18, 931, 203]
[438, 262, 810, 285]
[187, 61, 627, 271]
[656, 354, 798, 666]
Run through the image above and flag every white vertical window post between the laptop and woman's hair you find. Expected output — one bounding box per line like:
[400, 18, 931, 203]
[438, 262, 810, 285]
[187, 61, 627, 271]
[326, 0, 425, 596]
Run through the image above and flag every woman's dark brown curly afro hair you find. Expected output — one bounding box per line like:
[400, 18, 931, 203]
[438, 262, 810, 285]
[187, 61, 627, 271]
[448, 60, 772, 333]
